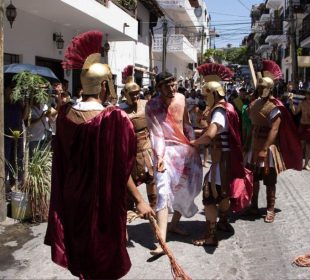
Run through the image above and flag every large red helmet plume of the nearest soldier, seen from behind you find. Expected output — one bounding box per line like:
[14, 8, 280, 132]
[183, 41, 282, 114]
[62, 30, 103, 69]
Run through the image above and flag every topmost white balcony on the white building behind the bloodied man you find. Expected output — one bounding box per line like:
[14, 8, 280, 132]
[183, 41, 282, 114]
[157, 0, 199, 31]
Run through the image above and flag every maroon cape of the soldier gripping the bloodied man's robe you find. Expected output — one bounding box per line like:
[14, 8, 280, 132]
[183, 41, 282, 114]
[225, 102, 253, 212]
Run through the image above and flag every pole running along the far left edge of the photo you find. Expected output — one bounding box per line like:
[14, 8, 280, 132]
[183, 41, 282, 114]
[0, 0, 7, 222]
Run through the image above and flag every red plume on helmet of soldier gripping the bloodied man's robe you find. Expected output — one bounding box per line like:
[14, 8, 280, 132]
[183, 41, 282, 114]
[197, 63, 234, 82]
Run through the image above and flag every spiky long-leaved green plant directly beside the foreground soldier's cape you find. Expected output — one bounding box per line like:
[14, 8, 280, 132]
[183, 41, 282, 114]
[21, 145, 52, 222]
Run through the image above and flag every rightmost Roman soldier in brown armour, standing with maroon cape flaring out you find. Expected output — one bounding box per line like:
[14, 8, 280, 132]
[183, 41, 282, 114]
[247, 61, 301, 223]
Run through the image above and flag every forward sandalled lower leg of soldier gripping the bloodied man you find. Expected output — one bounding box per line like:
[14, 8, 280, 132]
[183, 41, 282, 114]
[193, 204, 218, 246]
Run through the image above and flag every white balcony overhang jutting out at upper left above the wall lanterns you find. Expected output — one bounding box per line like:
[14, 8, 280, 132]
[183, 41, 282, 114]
[10, 0, 138, 41]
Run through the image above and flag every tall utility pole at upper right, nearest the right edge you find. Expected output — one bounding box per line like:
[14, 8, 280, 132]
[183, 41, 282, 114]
[289, 0, 298, 87]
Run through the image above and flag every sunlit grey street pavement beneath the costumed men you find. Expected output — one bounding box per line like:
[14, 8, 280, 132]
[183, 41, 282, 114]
[0, 167, 310, 280]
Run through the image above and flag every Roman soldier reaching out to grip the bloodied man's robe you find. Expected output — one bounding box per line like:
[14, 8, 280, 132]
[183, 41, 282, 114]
[194, 63, 252, 246]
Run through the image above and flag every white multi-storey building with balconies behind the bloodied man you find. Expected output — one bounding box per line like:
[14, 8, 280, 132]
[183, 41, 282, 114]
[153, 0, 210, 81]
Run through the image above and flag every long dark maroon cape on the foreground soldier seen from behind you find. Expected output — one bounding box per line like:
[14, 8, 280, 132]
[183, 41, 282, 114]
[45, 105, 136, 279]
